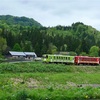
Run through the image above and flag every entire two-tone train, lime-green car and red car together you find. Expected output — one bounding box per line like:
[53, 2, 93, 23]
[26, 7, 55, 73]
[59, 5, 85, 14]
[42, 54, 100, 65]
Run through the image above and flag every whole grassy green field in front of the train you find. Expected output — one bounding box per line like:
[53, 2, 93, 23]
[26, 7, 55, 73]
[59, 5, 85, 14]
[0, 62, 100, 100]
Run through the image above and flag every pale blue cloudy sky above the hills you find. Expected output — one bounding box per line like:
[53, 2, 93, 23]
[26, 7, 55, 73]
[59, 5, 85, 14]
[0, 0, 100, 31]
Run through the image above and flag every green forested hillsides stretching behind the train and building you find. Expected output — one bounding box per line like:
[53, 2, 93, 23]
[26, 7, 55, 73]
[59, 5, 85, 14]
[0, 15, 100, 57]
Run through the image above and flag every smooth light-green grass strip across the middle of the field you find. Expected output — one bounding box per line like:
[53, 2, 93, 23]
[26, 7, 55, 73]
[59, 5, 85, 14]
[0, 73, 100, 86]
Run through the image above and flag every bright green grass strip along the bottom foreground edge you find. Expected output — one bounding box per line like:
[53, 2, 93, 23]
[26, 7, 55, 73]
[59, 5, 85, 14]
[0, 87, 100, 100]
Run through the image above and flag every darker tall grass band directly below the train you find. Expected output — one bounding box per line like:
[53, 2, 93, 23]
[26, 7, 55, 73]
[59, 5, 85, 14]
[0, 62, 100, 73]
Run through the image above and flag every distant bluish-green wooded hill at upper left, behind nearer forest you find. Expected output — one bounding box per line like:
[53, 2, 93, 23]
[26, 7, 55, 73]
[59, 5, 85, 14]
[0, 15, 42, 27]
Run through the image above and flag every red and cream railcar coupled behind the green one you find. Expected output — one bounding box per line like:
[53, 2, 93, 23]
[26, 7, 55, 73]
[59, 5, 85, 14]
[74, 56, 99, 65]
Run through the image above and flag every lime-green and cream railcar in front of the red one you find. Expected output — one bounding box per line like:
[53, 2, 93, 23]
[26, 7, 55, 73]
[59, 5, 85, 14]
[43, 54, 75, 64]
